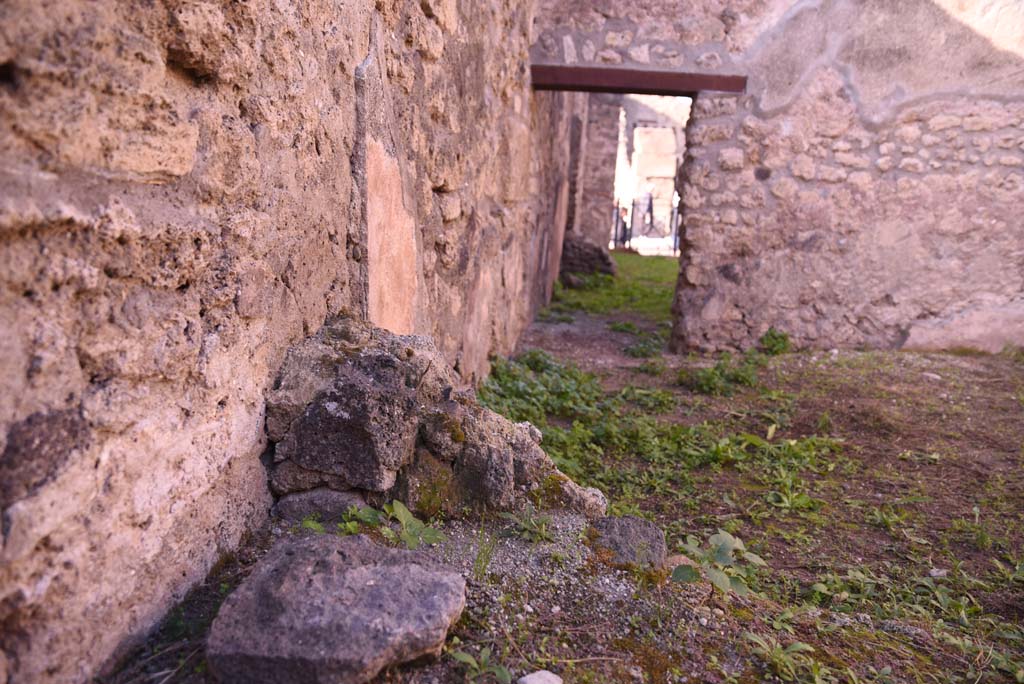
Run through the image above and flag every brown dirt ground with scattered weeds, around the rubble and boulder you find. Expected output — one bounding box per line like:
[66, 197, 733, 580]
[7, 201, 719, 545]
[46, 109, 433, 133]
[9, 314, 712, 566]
[102, 257, 1024, 684]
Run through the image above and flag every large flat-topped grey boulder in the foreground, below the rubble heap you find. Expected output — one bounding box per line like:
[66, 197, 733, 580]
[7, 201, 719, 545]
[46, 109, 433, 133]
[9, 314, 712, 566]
[207, 535, 466, 684]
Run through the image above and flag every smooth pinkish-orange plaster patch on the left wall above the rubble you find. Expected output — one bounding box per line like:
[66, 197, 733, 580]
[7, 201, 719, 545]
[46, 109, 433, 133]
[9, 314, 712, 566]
[367, 138, 419, 334]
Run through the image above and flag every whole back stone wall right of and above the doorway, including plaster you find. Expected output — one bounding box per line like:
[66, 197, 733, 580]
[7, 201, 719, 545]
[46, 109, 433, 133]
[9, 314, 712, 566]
[531, 0, 1024, 350]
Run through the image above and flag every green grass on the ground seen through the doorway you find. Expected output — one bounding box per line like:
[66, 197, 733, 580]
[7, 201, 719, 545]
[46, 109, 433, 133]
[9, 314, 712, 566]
[551, 252, 679, 322]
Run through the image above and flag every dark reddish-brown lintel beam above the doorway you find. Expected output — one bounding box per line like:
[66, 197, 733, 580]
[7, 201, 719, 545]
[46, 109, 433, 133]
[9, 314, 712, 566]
[530, 65, 746, 97]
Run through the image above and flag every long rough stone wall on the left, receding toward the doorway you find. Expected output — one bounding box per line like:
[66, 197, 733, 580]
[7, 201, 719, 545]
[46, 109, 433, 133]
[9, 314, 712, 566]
[0, 0, 568, 683]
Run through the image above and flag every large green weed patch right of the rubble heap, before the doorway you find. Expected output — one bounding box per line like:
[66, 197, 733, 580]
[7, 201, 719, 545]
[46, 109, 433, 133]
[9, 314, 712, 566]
[479, 351, 839, 511]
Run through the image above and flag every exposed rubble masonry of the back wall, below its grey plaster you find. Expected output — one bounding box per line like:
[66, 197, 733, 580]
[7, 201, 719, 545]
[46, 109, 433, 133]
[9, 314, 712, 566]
[675, 87, 1024, 351]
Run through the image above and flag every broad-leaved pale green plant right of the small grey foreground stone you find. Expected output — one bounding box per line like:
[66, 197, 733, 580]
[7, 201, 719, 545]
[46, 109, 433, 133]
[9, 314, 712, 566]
[672, 529, 765, 596]
